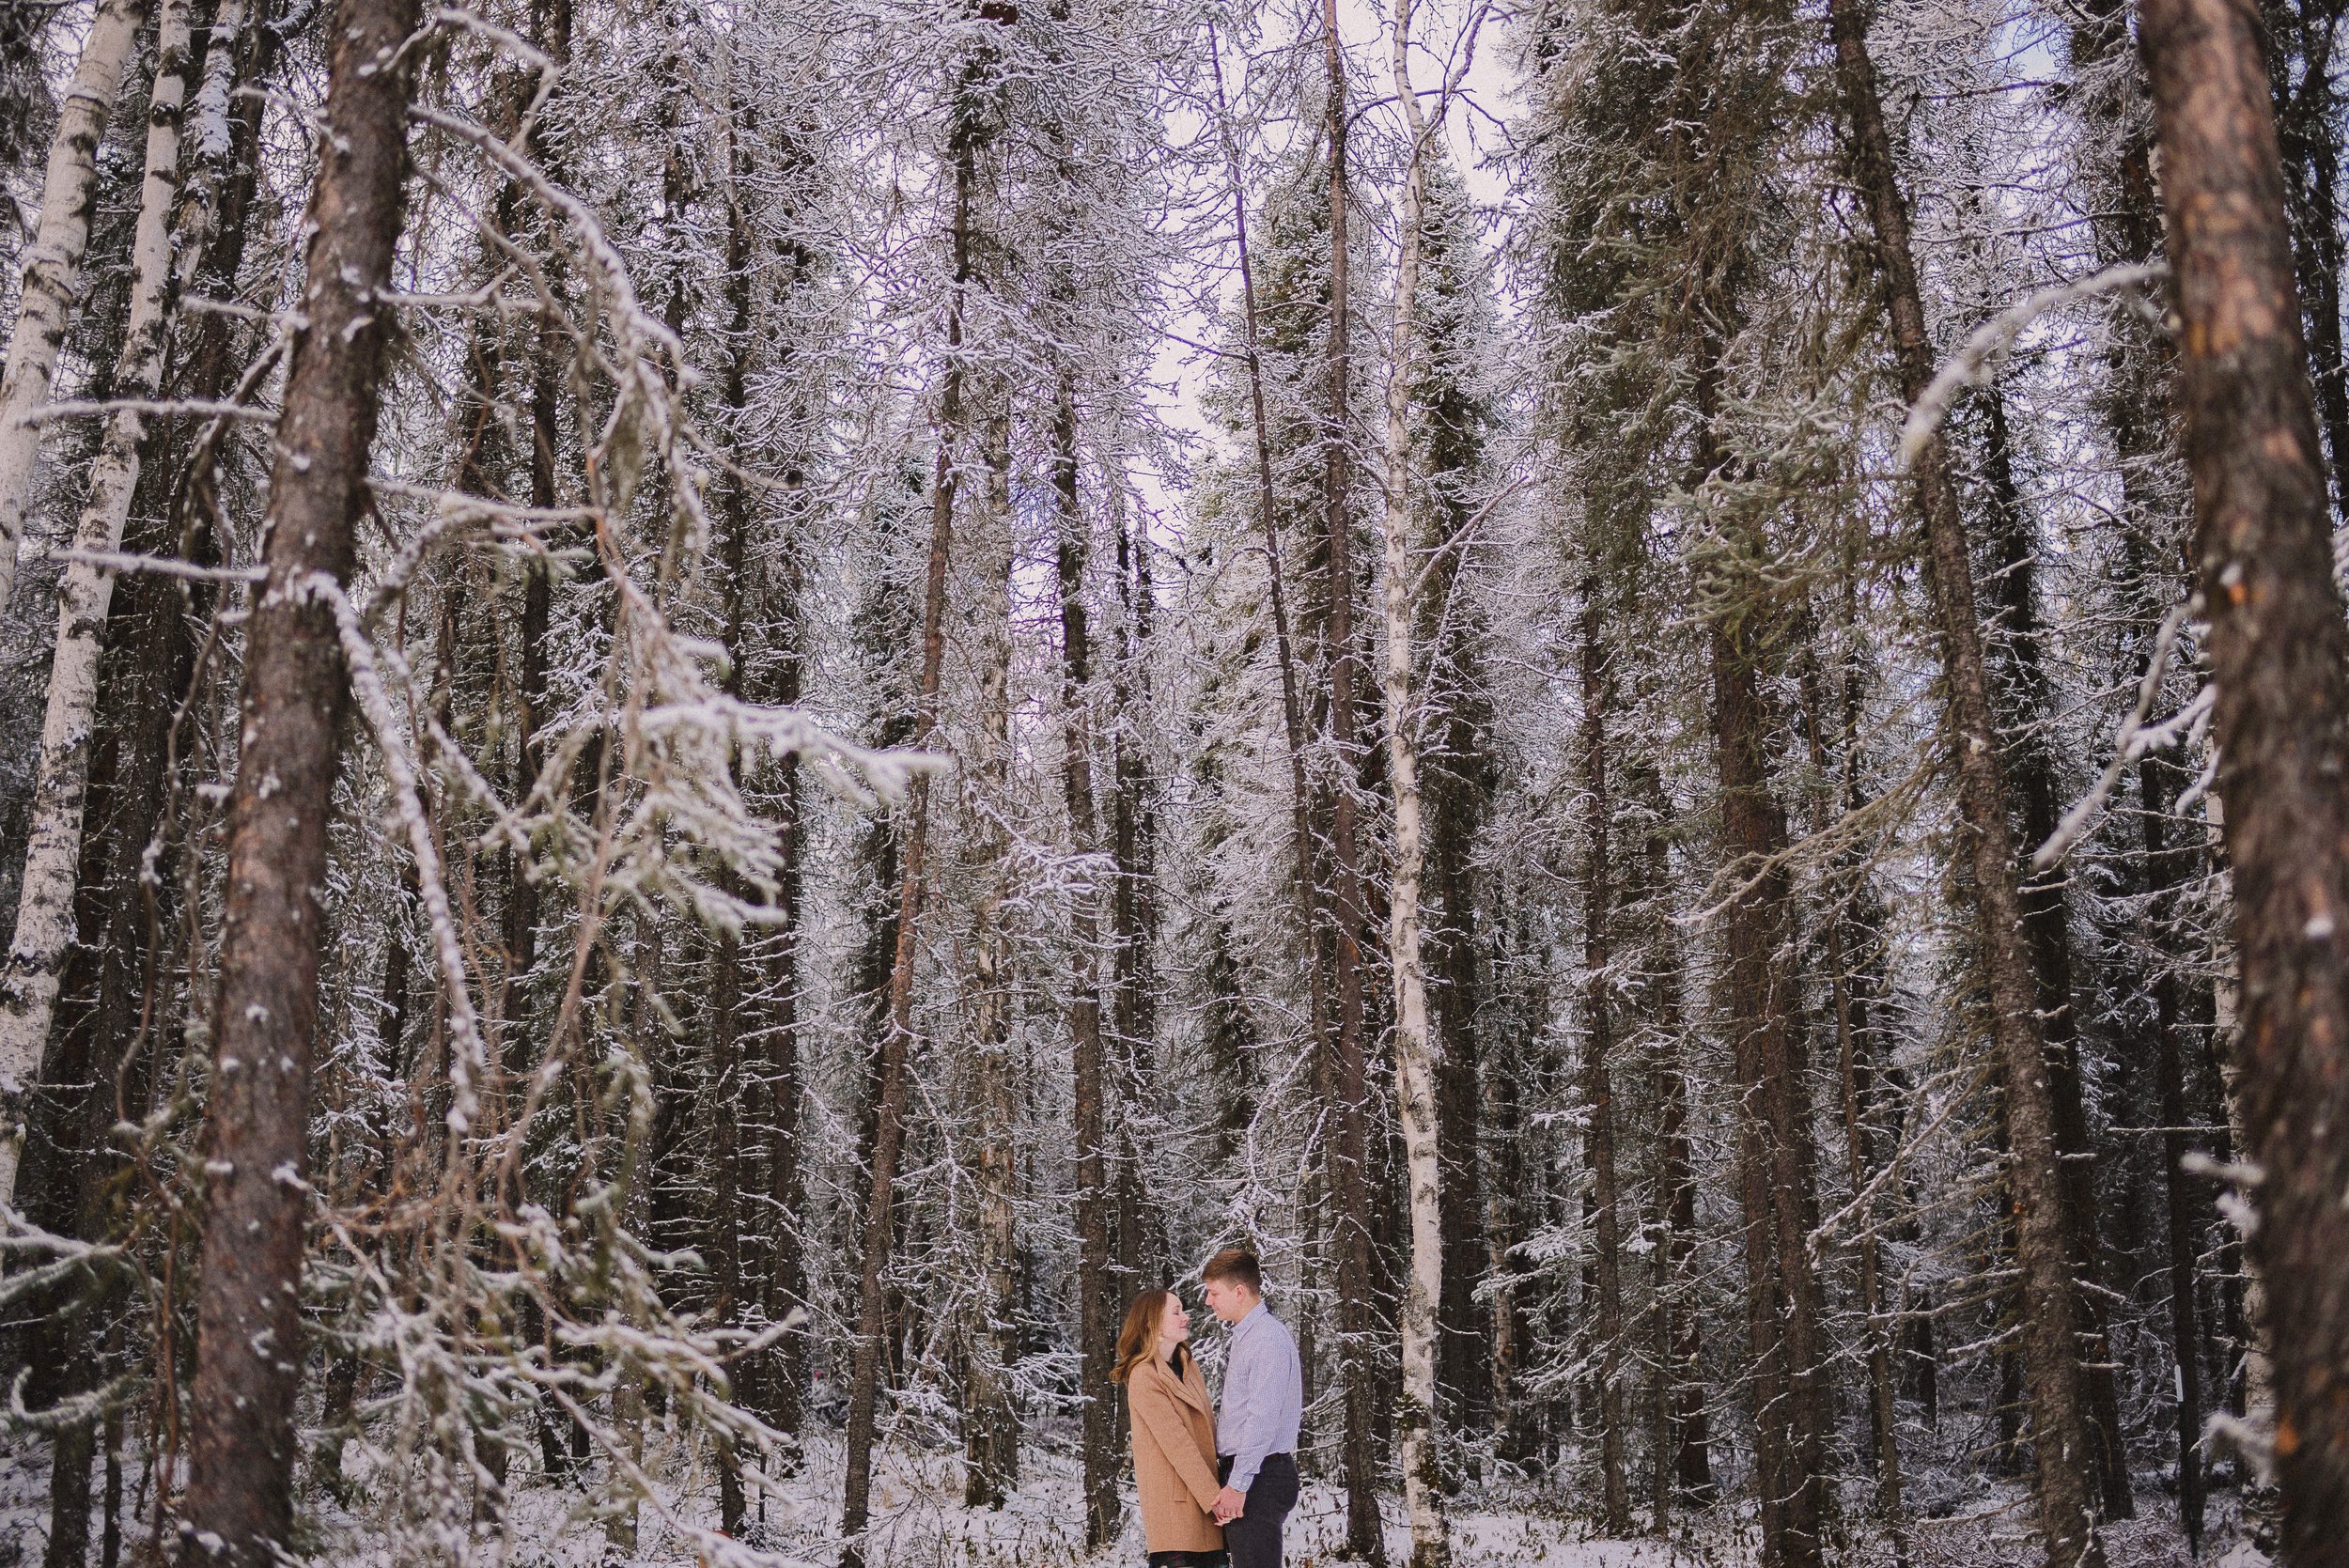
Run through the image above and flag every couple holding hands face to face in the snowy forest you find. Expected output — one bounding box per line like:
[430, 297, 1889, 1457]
[1112, 1247, 1304, 1568]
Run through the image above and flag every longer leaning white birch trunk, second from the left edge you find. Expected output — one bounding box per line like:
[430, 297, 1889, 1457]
[0, 0, 199, 1206]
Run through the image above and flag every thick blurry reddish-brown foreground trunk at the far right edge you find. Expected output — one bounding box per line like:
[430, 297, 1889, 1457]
[2138, 0, 2349, 1568]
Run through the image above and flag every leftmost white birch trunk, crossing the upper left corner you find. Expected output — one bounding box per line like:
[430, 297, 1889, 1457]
[0, 0, 146, 610]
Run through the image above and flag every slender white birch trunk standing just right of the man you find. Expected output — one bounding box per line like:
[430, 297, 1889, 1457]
[1384, 0, 1452, 1568]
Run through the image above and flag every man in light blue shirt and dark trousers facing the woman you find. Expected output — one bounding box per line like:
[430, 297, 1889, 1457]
[1203, 1247, 1306, 1568]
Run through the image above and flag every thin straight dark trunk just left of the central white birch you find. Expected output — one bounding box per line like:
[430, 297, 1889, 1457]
[1323, 0, 1386, 1563]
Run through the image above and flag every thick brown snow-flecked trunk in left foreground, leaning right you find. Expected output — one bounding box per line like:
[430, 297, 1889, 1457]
[186, 0, 418, 1568]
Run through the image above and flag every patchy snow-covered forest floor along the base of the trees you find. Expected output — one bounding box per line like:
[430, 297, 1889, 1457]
[0, 1436, 2269, 1568]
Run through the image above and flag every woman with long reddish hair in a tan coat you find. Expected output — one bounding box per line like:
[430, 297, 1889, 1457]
[1109, 1291, 1231, 1568]
